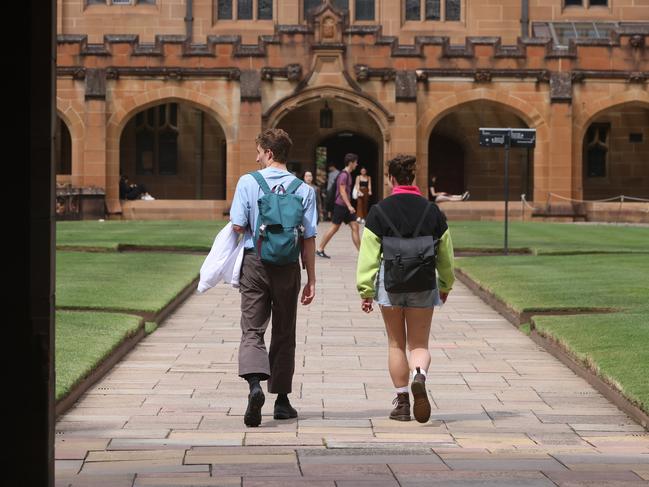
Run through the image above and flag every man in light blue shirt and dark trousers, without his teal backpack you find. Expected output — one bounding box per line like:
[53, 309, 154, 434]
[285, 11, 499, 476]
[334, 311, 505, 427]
[230, 129, 317, 426]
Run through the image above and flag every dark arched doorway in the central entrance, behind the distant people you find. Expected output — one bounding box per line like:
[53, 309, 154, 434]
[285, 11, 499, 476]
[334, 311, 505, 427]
[314, 132, 383, 205]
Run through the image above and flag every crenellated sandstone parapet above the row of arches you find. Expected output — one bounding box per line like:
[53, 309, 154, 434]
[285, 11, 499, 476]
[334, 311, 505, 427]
[57, 12, 649, 106]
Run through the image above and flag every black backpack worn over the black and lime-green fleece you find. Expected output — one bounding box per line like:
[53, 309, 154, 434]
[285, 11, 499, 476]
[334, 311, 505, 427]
[376, 204, 438, 293]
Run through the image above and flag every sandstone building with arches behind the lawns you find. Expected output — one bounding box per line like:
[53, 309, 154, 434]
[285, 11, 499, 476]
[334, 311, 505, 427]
[56, 0, 649, 221]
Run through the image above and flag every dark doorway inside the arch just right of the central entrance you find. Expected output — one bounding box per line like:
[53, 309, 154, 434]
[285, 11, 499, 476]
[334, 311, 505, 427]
[427, 133, 465, 196]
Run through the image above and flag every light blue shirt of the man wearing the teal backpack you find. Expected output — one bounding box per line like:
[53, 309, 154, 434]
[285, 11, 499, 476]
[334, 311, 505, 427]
[230, 167, 318, 249]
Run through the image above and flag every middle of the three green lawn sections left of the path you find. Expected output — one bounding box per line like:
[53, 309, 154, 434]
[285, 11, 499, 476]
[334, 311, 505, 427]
[56, 251, 205, 312]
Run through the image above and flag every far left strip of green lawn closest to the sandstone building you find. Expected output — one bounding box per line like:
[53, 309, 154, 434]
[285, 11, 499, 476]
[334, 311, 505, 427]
[56, 220, 227, 251]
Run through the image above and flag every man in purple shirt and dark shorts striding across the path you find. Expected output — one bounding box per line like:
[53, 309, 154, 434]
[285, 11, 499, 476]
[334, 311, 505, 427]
[316, 153, 361, 259]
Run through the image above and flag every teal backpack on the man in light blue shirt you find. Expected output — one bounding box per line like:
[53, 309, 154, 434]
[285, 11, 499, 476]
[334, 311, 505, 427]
[250, 171, 304, 265]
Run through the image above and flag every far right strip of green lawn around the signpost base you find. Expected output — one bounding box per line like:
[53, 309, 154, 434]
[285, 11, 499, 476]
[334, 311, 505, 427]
[449, 221, 649, 254]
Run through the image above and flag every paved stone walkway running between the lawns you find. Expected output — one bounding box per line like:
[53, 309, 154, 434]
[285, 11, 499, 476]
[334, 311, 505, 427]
[56, 224, 649, 487]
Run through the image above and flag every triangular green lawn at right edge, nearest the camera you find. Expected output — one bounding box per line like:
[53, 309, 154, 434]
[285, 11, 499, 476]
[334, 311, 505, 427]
[534, 306, 649, 411]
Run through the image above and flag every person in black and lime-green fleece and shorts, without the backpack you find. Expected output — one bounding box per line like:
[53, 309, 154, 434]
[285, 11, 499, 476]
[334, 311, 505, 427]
[356, 155, 455, 423]
